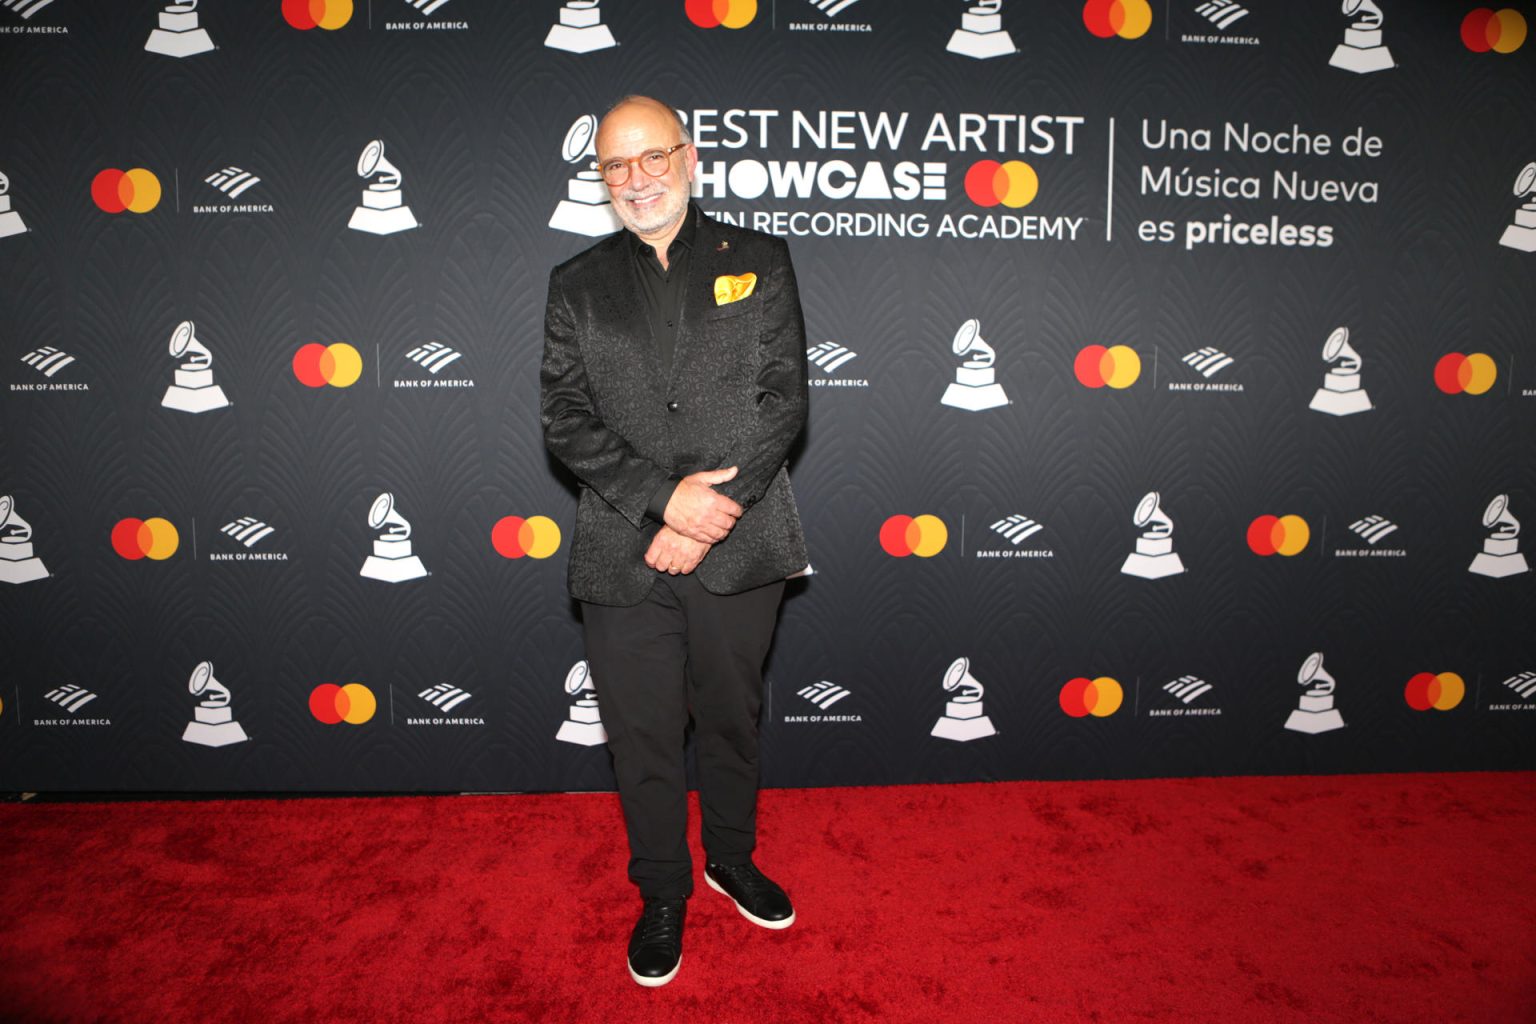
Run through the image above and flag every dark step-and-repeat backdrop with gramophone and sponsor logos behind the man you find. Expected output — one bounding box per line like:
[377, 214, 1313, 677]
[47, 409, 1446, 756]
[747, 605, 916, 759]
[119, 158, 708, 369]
[0, 0, 1536, 792]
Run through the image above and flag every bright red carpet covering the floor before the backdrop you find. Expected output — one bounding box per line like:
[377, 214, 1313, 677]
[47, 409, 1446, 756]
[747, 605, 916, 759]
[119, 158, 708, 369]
[0, 774, 1536, 1024]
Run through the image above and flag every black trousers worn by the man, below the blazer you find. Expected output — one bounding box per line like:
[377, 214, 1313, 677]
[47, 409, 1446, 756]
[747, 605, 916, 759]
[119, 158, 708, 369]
[582, 574, 783, 898]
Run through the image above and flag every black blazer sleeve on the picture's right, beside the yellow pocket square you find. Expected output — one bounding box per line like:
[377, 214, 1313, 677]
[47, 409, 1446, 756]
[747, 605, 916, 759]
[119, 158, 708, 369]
[714, 238, 808, 508]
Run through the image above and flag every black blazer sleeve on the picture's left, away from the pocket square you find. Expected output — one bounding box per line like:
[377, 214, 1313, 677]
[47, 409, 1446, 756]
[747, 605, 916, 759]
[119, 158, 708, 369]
[539, 267, 671, 530]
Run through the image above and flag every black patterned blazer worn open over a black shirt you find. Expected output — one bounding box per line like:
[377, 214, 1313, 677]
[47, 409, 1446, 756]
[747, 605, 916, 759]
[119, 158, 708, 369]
[539, 212, 806, 605]
